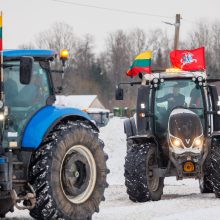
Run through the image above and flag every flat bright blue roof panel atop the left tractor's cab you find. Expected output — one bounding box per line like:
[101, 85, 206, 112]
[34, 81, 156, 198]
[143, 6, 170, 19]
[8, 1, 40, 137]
[3, 50, 57, 60]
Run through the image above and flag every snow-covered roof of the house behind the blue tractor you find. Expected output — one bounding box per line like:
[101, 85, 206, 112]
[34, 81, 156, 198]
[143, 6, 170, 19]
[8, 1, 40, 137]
[55, 95, 97, 109]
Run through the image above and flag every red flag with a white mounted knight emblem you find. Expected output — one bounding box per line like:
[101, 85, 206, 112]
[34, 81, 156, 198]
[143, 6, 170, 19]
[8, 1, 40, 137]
[170, 47, 206, 71]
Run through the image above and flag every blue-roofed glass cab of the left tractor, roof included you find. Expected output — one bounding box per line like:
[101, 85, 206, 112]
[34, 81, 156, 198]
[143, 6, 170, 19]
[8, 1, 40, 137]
[3, 50, 56, 147]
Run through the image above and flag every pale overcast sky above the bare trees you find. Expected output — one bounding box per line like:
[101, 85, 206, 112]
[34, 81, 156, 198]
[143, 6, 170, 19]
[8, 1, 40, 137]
[0, 0, 220, 50]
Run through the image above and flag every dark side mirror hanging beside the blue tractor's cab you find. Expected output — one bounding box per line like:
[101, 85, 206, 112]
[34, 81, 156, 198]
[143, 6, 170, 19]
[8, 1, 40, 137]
[20, 57, 34, 85]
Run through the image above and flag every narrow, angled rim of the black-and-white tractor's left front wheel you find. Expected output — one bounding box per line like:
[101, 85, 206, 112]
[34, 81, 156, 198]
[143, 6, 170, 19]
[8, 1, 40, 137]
[147, 154, 160, 192]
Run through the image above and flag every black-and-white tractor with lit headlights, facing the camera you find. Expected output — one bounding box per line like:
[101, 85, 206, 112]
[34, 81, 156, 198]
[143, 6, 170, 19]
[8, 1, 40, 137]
[116, 71, 220, 202]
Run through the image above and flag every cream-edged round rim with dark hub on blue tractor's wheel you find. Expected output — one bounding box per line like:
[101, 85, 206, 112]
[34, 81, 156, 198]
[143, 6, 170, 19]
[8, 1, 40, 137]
[60, 145, 97, 204]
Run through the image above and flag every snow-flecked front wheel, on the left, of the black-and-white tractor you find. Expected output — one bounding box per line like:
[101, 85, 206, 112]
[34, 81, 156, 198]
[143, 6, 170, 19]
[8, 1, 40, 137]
[124, 143, 164, 202]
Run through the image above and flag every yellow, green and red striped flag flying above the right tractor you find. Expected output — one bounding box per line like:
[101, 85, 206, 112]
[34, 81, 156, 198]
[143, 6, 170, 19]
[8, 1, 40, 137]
[127, 50, 152, 77]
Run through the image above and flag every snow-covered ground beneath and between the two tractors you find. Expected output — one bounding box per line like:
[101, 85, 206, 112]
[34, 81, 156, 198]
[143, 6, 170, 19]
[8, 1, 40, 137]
[4, 118, 220, 220]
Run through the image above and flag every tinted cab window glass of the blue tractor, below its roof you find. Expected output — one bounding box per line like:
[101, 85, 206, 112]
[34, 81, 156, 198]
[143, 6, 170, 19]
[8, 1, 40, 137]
[4, 61, 51, 147]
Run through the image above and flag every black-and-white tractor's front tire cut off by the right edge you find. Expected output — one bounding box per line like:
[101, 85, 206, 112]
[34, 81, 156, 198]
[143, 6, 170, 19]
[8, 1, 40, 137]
[207, 140, 220, 198]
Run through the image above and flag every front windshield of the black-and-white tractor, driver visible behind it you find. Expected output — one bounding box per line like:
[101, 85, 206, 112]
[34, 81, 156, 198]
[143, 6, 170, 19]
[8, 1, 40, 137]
[152, 73, 205, 141]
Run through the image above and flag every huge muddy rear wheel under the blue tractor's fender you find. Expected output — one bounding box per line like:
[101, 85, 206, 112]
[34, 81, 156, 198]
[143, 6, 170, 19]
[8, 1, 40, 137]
[29, 121, 108, 220]
